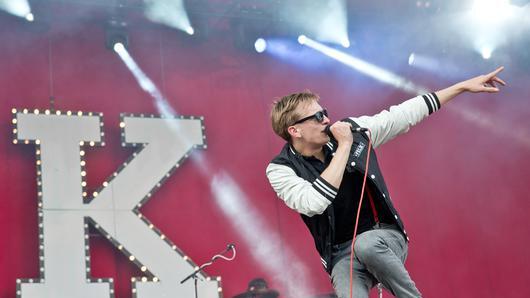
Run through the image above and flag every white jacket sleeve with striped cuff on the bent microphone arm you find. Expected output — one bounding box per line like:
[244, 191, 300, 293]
[267, 163, 338, 216]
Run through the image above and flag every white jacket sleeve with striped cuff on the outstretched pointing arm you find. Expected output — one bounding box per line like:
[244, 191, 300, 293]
[350, 93, 440, 148]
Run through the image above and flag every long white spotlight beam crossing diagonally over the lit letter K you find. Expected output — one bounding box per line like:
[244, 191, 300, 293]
[113, 42, 314, 297]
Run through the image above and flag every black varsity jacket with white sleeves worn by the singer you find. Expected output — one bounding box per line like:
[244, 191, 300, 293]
[266, 93, 440, 273]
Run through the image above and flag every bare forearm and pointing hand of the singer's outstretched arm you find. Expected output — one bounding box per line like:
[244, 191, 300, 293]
[435, 67, 506, 105]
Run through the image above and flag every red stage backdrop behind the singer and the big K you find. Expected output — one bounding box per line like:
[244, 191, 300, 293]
[0, 1, 530, 297]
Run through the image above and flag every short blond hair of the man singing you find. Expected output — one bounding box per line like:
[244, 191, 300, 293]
[271, 90, 320, 142]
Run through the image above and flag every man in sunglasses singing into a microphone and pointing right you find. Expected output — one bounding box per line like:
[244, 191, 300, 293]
[267, 67, 505, 298]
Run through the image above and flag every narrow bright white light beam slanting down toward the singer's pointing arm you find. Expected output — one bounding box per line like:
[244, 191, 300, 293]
[298, 37, 428, 94]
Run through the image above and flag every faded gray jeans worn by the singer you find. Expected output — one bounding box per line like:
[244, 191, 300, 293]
[331, 224, 421, 298]
